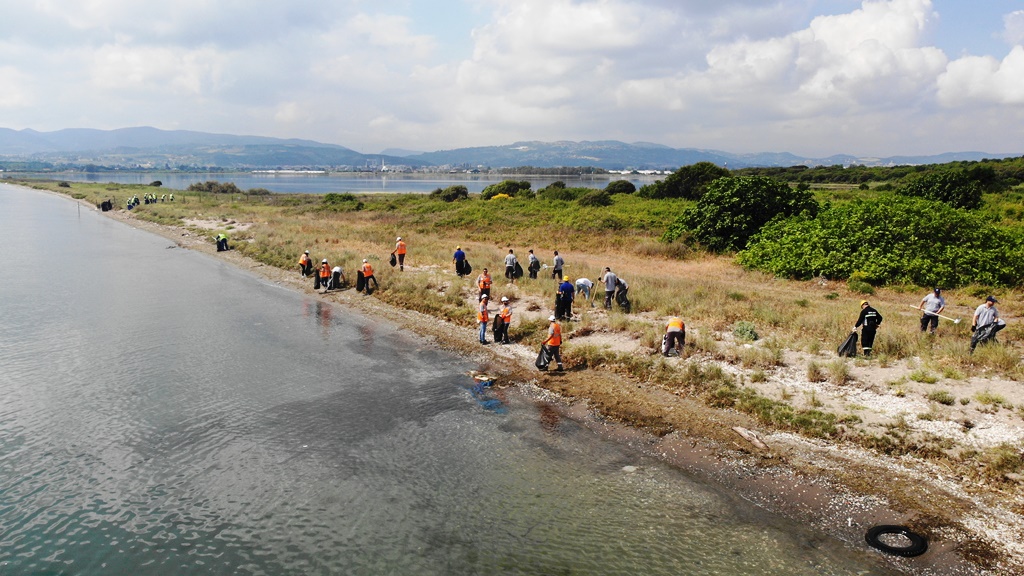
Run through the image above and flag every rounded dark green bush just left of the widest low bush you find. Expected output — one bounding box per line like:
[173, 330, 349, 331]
[662, 176, 818, 252]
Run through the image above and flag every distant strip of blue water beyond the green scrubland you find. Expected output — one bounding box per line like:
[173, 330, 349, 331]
[3, 171, 656, 194]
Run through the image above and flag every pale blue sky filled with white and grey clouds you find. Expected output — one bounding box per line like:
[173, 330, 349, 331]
[0, 0, 1024, 158]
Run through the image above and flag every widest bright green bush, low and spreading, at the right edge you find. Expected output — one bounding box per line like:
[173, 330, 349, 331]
[738, 195, 1024, 288]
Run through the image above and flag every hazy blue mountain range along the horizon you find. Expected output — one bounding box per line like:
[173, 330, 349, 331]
[0, 127, 1021, 170]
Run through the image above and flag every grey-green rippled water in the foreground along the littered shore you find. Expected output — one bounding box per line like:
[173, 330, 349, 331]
[0, 184, 888, 575]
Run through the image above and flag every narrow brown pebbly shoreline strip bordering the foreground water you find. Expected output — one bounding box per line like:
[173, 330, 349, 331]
[36, 189, 1024, 574]
